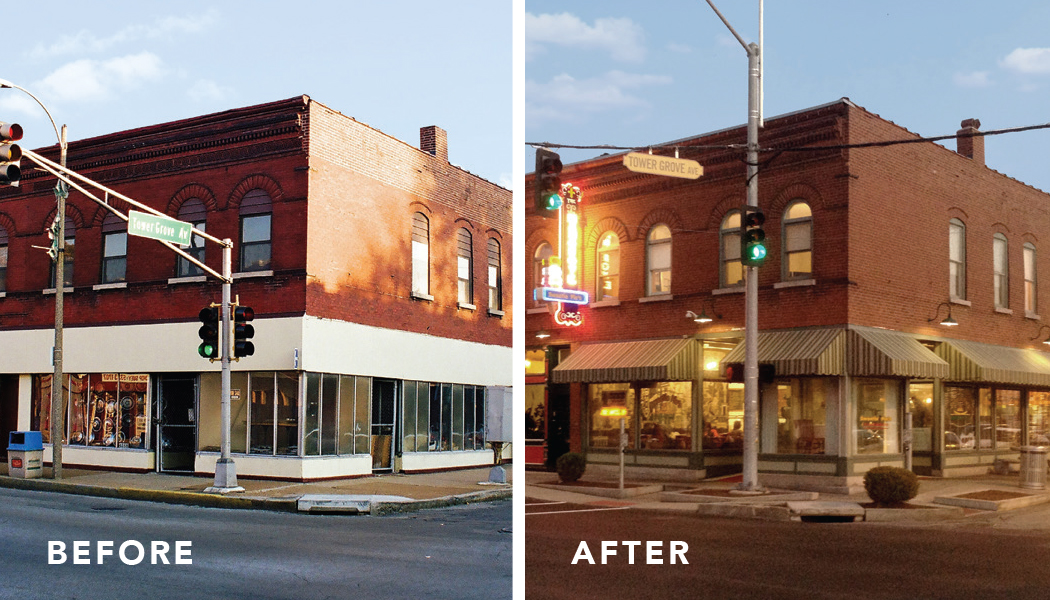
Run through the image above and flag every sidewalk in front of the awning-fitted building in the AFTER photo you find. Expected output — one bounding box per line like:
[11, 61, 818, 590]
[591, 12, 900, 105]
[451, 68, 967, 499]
[522, 471, 1050, 530]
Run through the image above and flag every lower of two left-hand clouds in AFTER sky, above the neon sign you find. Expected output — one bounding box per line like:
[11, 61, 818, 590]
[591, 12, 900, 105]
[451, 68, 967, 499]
[525, 70, 672, 120]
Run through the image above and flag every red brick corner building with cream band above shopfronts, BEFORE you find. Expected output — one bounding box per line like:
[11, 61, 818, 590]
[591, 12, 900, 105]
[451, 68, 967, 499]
[0, 96, 512, 479]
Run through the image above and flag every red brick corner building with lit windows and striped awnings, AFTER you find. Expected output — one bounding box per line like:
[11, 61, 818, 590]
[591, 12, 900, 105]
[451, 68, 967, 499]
[525, 99, 1050, 490]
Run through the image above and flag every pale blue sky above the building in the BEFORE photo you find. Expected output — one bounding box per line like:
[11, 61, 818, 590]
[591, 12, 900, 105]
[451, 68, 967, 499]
[0, 0, 513, 187]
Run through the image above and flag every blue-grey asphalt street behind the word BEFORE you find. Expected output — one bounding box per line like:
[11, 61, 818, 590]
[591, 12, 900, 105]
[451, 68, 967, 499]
[0, 490, 512, 599]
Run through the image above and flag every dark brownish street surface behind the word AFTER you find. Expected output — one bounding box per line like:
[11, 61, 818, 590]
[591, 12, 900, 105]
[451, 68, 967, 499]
[525, 499, 1050, 600]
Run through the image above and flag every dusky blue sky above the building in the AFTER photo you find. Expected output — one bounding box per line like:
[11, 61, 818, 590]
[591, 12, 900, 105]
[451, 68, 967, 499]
[524, 0, 1050, 191]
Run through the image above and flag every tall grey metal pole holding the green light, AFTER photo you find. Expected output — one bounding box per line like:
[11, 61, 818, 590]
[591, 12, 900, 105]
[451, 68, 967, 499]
[707, 0, 762, 492]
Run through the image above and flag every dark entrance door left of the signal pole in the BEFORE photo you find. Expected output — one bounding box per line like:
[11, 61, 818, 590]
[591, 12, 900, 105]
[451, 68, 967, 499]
[156, 375, 197, 473]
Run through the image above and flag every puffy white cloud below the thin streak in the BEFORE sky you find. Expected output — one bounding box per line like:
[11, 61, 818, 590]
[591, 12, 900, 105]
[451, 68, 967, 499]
[35, 51, 164, 102]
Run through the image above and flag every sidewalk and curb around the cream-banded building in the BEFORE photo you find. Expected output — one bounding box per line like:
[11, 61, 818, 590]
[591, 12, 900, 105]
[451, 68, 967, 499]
[0, 463, 512, 515]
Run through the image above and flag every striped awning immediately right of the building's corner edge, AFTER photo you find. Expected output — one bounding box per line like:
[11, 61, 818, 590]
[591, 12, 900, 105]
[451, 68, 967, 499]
[846, 329, 948, 379]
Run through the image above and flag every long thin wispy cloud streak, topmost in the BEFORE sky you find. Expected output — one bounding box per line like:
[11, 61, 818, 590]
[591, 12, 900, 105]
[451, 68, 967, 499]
[29, 8, 219, 59]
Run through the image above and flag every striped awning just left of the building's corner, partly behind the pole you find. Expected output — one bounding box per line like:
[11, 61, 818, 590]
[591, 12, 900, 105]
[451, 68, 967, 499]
[722, 329, 845, 376]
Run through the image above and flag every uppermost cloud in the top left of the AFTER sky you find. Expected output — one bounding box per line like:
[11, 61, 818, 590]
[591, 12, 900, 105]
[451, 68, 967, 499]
[525, 13, 646, 62]
